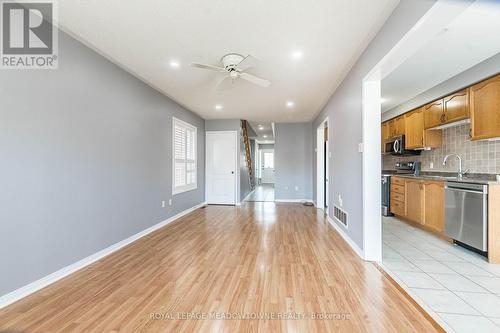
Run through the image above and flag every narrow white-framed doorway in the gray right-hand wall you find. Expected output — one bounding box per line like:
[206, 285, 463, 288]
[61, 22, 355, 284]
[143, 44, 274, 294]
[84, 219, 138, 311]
[316, 118, 330, 210]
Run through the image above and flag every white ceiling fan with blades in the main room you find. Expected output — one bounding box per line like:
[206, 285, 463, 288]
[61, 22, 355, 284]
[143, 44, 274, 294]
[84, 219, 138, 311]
[191, 53, 271, 88]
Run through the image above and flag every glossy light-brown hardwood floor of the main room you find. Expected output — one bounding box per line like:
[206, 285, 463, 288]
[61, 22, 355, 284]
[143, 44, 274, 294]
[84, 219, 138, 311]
[0, 203, 436, 332]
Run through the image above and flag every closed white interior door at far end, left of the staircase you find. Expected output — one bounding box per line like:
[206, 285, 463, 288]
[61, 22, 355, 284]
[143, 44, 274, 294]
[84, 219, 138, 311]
[205, 131, 238, 205]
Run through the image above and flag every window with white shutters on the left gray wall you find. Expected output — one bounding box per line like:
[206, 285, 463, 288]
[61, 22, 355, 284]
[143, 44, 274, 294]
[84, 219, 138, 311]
[172, 118, 197, 194]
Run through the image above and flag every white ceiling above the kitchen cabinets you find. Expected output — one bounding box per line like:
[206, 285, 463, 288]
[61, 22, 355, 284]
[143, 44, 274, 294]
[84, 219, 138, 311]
[382, 0, 500, 112]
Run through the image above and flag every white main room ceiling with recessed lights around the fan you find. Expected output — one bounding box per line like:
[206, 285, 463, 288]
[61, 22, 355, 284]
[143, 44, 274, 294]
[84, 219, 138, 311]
[59, 0, 398, 122]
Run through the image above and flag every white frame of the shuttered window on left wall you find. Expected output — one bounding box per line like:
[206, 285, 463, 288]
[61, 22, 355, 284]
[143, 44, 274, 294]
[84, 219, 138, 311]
[172, 117, 198, 196]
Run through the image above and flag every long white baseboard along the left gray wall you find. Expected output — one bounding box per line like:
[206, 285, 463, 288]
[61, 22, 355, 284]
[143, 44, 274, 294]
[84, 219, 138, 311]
[0, 202, 206, 309]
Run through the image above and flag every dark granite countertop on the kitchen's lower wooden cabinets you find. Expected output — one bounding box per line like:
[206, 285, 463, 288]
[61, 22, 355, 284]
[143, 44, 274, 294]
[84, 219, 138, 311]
[382, 170, 500, 185]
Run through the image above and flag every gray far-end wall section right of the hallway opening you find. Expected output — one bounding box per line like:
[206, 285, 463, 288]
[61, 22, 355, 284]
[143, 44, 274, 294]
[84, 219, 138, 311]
[274, 123, 312, 200]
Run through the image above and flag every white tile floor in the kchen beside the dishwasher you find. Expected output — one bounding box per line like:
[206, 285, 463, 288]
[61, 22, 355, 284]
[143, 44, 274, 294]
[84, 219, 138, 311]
[382, 217, 500, 333]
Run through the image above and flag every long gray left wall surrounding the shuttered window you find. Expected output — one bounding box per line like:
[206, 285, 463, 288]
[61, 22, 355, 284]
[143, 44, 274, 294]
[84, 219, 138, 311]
[0, 28, 205, 295]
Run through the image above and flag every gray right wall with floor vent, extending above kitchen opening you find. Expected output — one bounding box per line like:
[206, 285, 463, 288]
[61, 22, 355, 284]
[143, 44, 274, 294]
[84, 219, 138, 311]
[312, 0, 434, 249]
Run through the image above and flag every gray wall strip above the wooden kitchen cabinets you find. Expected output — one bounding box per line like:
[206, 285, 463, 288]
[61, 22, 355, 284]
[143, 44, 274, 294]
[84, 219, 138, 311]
[382, 53, 500, 120]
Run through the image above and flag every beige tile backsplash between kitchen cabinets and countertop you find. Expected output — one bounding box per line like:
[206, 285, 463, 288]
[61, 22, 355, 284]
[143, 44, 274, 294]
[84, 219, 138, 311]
[382, 124, 500, 174]
